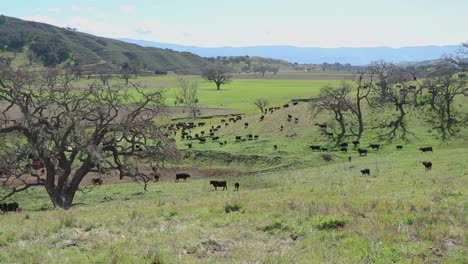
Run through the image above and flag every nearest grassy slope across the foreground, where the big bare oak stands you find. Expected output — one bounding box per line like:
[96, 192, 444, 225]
[0, 142, 468, 263]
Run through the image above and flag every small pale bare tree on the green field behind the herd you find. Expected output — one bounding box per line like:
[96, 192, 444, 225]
[176, 78, 200, 119]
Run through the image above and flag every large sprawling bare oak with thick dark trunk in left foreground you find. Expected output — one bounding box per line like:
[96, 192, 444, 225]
[0, 64, 178, 209]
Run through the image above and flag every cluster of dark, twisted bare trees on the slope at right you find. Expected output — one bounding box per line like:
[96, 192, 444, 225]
[312, 43, 468, 144]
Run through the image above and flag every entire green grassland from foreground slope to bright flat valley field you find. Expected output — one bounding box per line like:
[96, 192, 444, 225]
[0, 72, 468, 263]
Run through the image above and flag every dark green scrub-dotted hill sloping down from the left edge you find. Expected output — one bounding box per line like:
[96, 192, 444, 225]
[0, 16, 211, 73]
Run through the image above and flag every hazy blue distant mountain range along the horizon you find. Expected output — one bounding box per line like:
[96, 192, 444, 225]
[119, 38, 460, 65]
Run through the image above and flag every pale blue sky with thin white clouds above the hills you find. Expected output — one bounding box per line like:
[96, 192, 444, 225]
[0, 0, 468, 48]
